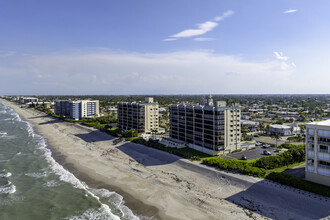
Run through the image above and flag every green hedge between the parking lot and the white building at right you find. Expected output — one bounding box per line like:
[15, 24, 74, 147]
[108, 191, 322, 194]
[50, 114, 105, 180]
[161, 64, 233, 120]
[252, 146, 305, 169]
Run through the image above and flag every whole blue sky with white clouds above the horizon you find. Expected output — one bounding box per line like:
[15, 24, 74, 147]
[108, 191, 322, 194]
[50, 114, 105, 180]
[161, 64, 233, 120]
[0, 0, 330, 95]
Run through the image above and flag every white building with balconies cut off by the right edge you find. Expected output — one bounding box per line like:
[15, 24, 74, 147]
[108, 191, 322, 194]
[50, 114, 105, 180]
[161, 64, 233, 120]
[305, 120, 330, 186]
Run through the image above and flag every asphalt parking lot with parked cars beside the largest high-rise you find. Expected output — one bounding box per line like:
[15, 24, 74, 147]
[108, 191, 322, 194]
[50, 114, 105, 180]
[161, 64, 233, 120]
[221, 146, 279, 160]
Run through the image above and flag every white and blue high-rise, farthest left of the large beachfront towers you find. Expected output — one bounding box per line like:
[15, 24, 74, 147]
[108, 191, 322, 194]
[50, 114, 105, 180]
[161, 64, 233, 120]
[55, 100, 100, 120]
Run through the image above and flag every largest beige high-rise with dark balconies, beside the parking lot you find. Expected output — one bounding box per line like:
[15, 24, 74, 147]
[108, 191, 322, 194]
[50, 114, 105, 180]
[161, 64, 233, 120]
[170, 96, 241, 155]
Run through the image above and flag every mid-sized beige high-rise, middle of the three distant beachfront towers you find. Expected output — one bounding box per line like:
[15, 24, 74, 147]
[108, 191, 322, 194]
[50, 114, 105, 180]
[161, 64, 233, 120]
[117, 97, 159, 133]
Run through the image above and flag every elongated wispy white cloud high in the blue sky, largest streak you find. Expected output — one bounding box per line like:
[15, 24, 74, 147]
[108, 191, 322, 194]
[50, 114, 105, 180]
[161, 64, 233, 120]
[164, 11, 234, 41]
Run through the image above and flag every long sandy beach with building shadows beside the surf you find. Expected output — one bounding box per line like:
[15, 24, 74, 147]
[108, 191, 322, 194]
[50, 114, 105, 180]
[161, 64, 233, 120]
[0, 99, 330, 220]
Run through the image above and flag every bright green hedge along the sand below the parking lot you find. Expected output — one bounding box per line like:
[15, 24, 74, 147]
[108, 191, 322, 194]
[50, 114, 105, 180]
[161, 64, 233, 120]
[202, 157, 266, 177]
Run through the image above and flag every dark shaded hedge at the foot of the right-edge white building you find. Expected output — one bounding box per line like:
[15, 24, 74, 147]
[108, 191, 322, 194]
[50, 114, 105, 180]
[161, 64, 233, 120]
[266, 172, 330, 197]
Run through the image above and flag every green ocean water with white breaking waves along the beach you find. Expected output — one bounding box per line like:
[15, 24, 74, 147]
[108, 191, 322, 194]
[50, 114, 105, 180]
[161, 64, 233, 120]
[0, 103, 144, 220]
